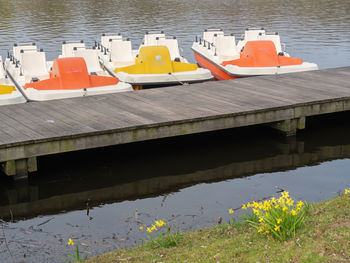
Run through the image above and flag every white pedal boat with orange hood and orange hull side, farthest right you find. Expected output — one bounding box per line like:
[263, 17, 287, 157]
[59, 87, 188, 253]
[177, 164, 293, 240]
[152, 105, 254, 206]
[192, 28, 318, 80]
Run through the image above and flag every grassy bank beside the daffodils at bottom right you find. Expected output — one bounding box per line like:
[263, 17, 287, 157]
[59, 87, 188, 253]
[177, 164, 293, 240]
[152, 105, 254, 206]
[87, 195, 350, 263]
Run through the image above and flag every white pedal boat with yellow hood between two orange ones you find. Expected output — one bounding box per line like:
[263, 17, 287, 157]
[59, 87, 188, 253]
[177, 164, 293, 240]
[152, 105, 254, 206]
[98, 32, 213, 89]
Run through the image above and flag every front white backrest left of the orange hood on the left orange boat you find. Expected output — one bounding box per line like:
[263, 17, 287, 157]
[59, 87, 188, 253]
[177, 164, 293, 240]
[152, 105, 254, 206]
[21, 51, 48, 77]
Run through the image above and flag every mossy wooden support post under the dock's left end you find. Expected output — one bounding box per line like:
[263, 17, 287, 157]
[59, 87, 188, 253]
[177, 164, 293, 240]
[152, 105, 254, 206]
[2, 157, 38, 180]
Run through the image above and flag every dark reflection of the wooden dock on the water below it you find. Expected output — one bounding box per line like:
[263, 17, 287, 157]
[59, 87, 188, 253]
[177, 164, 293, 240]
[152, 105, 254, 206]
[0, 113, 350, 220]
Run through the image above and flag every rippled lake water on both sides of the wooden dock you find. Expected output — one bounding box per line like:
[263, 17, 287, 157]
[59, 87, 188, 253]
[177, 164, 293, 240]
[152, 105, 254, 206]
[0, 0, 350, 262]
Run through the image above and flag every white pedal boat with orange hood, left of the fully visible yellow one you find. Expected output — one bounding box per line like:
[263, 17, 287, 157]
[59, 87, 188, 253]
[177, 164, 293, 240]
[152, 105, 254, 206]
[5, 44, 132, 101]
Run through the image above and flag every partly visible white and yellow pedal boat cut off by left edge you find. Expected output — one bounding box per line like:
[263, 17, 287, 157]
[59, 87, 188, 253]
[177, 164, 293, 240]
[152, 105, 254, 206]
[0, 56, 26, 106]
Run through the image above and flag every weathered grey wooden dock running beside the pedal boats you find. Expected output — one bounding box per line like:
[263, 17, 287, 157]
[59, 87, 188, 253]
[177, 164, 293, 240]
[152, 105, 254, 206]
[0, 67, 350, 178]
